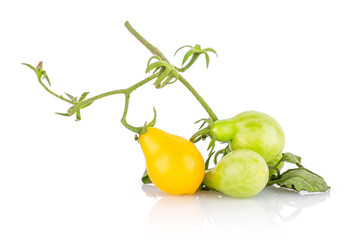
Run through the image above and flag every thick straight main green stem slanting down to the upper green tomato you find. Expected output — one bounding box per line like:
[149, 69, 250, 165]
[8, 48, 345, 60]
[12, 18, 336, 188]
[125, 21, 218, 121]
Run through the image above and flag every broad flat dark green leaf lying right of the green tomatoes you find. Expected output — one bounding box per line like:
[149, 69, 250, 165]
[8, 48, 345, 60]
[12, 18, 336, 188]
[274, 168, 330, 192]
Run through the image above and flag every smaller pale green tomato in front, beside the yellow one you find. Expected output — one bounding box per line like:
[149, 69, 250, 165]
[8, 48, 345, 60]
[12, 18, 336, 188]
[203, 149, 269, 198]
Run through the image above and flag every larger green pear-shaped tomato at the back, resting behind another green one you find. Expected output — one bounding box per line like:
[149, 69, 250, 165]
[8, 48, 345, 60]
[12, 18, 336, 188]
[211, 111, 285, 163]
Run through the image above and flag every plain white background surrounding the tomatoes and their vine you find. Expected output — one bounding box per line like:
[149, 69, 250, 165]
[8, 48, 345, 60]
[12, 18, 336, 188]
[0, 0, 360, 240]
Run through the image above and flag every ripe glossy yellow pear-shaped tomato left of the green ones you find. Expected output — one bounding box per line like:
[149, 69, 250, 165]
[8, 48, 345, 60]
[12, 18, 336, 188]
[139, 128, 205, 195]
